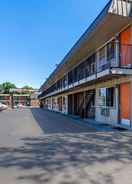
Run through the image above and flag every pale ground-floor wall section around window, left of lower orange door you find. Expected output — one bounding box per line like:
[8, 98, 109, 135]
[95, 87, 119, 124]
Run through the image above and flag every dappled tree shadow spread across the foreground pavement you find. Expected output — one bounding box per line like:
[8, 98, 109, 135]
[0, 132, 132, 184]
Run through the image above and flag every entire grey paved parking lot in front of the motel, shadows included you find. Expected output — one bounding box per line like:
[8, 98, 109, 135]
[0, 109, 132, 184]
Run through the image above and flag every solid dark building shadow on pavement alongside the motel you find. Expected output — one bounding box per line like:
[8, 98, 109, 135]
[31, 108, 96, 133]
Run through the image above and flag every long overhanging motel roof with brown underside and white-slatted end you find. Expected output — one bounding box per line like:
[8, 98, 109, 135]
[40, 0, 132, 90]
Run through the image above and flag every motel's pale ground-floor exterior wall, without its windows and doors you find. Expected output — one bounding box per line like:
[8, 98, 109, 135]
[40, 76, 132, 128]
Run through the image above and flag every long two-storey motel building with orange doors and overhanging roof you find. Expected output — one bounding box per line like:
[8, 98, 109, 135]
[39, 0, 132, 128]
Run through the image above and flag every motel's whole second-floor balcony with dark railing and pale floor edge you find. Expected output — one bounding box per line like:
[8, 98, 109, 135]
[39, 41, 132, 99]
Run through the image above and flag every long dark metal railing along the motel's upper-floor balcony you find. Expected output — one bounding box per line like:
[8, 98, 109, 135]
[40, 42, 132, 97]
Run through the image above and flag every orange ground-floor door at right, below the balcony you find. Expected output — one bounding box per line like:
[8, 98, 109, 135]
[120, 83, 131, 126]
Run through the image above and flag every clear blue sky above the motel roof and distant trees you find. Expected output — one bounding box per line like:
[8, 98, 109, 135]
[0, 0, 108, 88]
